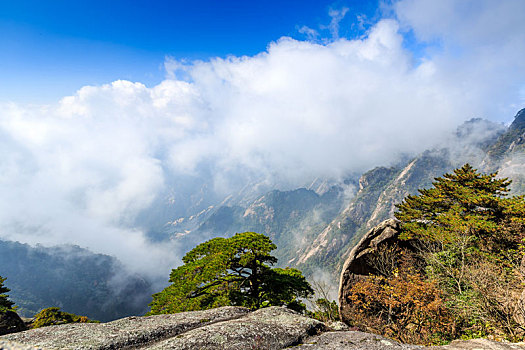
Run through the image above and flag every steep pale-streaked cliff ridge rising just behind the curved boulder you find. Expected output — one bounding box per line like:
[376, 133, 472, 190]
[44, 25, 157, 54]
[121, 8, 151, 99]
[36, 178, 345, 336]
[297, 151, 453, 273]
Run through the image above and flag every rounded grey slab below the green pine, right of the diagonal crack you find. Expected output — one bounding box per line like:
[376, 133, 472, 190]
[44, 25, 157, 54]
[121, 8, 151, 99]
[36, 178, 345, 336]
[146, 306, 326, 350]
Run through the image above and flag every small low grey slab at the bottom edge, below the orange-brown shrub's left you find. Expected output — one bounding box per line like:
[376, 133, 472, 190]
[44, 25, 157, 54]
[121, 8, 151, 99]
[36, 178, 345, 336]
[294, 331, 422, 350]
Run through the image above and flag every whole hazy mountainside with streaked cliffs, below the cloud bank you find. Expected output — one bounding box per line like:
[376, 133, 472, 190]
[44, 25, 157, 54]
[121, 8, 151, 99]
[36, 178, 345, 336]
[160, 109, 525, 284]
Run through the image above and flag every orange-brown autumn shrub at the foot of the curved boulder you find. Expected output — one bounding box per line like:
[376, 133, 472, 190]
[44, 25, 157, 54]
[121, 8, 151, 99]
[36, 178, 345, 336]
[350, 256, 456, 344]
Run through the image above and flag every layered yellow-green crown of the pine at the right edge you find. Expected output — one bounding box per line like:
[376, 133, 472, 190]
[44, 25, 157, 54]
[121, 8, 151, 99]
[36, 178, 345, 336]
[395, 164, 525, 253]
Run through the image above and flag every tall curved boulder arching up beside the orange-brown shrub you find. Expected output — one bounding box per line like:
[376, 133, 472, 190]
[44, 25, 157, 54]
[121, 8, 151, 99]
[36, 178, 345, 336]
[339, 219, 411, 323]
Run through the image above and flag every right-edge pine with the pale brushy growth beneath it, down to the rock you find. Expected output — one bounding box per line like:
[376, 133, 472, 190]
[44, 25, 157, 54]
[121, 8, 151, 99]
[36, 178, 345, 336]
[395, 164, 525, 339]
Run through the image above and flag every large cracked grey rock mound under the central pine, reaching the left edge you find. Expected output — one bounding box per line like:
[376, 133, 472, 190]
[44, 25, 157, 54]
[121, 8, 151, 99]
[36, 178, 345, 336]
[0, 306, 326, 350]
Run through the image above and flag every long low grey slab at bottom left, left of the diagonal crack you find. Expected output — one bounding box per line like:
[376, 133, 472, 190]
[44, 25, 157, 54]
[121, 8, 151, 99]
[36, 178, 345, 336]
[1, 306, 249, 349]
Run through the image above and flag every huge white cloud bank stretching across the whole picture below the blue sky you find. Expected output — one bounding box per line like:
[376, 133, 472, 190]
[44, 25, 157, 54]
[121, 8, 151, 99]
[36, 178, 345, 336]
[0, 0, 525, 276]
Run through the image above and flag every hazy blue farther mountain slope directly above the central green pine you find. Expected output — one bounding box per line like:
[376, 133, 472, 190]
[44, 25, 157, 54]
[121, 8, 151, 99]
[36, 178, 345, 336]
[184, 183, 351, 265]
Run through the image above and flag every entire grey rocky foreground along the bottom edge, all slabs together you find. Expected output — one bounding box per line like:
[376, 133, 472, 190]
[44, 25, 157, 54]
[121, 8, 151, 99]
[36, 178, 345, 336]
[0, 307, 525, 350]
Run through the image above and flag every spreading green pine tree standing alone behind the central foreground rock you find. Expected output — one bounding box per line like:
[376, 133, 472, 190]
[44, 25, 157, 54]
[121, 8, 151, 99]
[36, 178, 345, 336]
[149, 232, 313, 315]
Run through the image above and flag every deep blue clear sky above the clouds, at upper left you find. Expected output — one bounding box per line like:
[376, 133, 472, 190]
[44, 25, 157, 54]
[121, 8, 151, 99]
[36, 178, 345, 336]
[0, 0, 378, 103]
